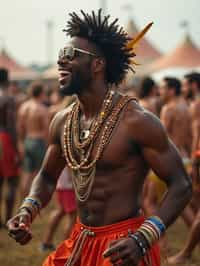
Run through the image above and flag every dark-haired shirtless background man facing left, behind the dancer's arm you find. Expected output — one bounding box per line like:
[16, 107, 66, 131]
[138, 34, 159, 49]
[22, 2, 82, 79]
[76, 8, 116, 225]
[160, 77, 192, 229]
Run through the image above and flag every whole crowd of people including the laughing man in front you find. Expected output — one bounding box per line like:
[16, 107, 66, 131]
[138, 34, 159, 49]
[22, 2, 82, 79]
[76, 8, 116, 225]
[0, 10, 200, 266]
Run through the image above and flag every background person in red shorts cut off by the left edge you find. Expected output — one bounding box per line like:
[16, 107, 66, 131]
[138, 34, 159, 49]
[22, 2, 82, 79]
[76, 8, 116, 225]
[0, 68, 18, 227]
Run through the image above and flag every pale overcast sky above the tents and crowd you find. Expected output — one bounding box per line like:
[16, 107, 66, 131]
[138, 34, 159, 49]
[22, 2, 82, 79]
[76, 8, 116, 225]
[0, 0, 200, 64]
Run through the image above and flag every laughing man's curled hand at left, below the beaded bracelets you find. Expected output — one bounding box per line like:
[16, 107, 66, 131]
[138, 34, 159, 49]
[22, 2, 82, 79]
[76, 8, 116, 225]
[7, 210, 32, 245]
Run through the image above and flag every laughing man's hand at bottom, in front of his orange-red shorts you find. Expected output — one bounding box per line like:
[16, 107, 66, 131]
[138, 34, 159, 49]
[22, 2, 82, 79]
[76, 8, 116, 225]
[103, 237, 142, 266]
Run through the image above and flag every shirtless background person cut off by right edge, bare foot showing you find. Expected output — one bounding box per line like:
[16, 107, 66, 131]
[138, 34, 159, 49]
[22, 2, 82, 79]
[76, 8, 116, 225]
[168, 73, 200, 264]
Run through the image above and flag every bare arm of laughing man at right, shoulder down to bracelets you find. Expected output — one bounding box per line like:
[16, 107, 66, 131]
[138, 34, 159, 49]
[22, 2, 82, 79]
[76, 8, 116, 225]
[137, 110, 192, 227]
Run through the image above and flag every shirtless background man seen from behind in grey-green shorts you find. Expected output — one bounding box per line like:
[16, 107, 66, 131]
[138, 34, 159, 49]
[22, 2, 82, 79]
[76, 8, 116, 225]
[17, 82, 49, 197]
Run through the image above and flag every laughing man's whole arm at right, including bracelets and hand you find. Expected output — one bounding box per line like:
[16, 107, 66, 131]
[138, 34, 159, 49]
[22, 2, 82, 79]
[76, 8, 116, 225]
[103, 107, 192, 265]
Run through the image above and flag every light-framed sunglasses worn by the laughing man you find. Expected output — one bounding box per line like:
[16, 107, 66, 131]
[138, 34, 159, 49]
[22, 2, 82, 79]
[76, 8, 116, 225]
[59, 46, 97, 61]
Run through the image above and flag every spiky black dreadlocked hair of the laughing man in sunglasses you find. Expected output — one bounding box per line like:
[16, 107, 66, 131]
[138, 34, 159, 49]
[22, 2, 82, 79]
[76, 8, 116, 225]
[64, 9, 135, 85]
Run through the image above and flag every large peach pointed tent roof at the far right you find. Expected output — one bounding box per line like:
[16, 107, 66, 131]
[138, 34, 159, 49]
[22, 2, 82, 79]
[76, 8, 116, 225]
[150, 33, 200, 72]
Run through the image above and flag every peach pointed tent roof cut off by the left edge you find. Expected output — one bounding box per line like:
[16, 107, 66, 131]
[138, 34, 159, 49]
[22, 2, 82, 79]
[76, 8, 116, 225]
[0, 49, 37, 80]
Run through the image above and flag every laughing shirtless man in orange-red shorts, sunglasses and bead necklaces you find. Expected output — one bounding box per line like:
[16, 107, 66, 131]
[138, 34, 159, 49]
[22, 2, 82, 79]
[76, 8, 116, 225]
[7, 11, 192, 266]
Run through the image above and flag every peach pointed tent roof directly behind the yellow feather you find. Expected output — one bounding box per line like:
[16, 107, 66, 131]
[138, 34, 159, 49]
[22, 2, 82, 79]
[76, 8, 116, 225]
[126, 19, 161, 63]
